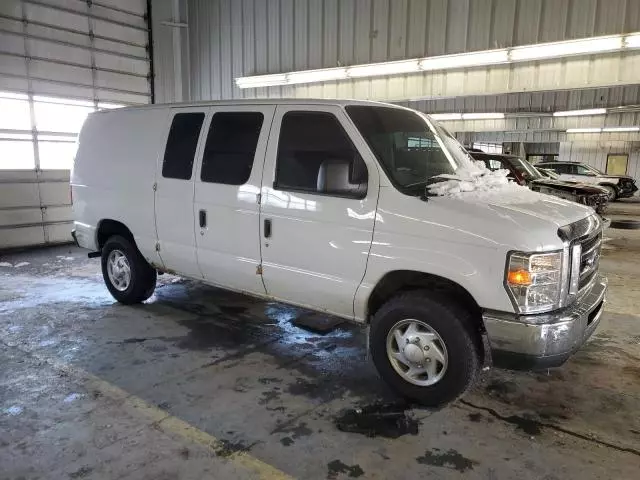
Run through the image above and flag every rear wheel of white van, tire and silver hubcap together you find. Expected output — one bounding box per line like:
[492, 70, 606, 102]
[102, 235, 156, 305]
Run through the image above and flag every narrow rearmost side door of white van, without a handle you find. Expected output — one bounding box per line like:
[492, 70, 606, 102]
[155, 107, 208, 277]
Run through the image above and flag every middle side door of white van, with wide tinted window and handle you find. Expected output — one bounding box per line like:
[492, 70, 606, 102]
[194, 105, 275, 295]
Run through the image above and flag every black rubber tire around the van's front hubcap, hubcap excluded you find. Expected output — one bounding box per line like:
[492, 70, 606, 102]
[370, 291, 480, 407]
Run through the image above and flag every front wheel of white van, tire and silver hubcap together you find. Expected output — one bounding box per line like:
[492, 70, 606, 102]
[370, 291, 480, 407]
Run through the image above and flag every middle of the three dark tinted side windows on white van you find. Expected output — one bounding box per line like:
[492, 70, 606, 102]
[200, 112, 264, 185]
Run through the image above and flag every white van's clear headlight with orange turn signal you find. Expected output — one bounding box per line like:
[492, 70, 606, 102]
[505, 251, 563, 314]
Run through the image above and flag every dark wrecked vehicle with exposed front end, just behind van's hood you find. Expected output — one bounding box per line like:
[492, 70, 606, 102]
[470, 151, 609, 215]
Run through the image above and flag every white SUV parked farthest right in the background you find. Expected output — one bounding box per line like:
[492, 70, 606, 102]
[536, 162, 638, 202]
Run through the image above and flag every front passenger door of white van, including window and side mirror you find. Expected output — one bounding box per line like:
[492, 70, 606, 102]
[260, 105, 379, 318]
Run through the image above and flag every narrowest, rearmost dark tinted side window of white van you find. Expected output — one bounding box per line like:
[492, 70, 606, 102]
[162, 112, 204, 180]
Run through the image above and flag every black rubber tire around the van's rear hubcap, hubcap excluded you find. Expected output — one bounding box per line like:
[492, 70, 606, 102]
[102, 235, 157, 305]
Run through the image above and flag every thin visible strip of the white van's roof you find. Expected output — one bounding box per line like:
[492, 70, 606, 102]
[100, 98, 407, 112]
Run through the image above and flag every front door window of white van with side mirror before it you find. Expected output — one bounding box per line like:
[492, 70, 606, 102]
[274, 112, 368, 198]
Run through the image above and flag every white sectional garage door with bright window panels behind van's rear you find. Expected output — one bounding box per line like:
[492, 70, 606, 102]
[0, 0, 152, 249]
